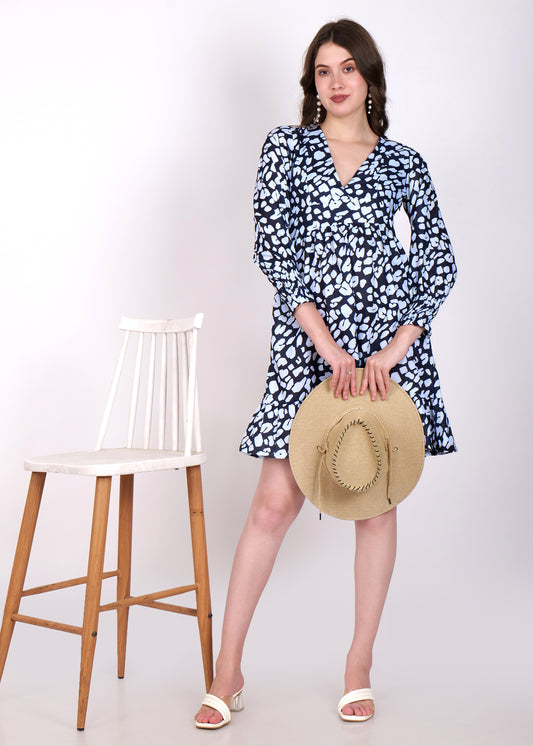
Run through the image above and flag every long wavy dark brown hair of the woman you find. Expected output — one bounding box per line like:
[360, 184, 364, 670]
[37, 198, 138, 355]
[300, 18, 389, 135]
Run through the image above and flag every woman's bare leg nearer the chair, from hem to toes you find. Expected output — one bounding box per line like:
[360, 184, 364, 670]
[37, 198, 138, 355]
[196, 458, 305, 723]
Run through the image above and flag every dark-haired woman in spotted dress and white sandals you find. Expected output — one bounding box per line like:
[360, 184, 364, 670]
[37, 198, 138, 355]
[196, 20, 456, 728]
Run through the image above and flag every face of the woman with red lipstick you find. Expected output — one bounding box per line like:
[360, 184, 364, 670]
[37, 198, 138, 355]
[315, 42, 368, 117]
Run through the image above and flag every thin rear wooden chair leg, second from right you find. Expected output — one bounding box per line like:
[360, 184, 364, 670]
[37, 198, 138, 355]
[117, 474, 133, 679]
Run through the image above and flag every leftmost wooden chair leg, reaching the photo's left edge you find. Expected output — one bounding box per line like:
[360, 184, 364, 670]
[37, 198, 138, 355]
[0, 471, 46, 679]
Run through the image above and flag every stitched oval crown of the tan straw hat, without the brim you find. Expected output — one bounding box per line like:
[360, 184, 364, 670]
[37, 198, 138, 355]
[324, 407, 388, 492]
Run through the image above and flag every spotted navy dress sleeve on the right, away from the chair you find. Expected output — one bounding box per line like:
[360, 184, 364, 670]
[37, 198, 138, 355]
[401, 154, 457, 331]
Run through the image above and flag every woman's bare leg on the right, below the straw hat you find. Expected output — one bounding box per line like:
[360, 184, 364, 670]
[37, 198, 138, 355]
[343, 508, 396, 715]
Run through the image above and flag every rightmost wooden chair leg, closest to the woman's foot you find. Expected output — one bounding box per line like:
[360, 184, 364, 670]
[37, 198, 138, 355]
[186, 466, 213, 691]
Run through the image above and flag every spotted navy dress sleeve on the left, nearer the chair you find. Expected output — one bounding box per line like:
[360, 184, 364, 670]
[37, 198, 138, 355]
[254, 127, 313, 311]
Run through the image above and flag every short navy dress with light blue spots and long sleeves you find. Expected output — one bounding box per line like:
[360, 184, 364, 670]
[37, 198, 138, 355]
[240, 126, 456, 458]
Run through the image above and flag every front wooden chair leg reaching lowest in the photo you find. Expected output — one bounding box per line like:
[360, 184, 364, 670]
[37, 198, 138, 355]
[78, 477, 111, 730]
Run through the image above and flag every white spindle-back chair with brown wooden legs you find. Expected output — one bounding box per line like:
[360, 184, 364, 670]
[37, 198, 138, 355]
[0, 314, 213, 730]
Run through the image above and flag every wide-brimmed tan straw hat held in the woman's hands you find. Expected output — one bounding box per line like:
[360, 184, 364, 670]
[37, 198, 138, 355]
[289, 369, 425, 520]
